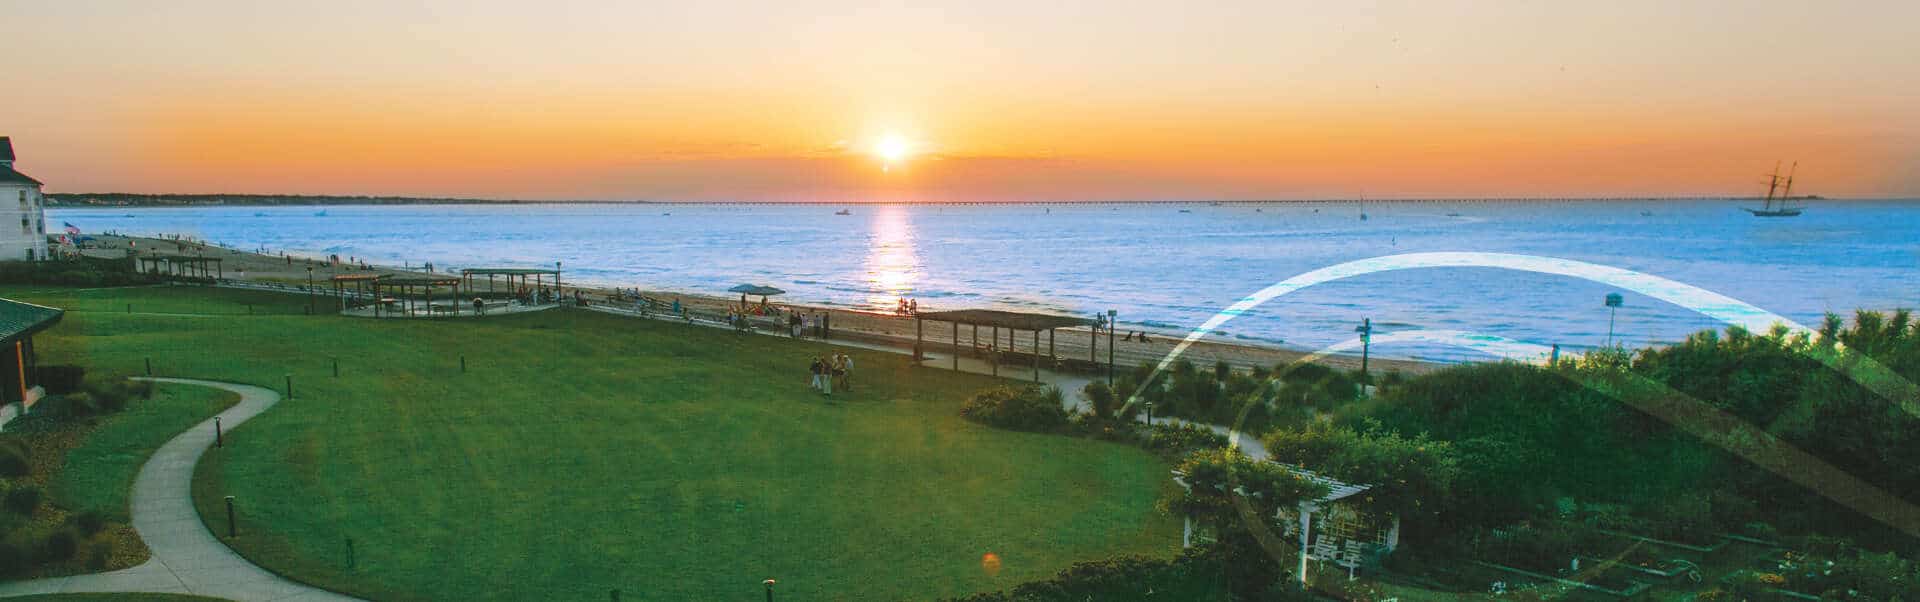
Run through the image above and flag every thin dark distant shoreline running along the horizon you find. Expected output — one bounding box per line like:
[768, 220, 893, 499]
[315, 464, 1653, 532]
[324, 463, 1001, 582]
[46, 192, 1835, 209]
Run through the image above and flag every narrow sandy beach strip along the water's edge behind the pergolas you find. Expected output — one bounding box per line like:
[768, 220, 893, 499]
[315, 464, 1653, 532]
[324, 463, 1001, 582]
[83, 234, 1442, 374]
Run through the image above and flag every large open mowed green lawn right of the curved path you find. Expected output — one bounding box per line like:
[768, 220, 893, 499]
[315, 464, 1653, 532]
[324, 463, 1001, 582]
[0, 288, 1179, 600]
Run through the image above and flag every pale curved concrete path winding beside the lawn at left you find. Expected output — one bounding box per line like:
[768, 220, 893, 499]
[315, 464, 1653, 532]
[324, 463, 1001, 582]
[0, 378, 357, 600]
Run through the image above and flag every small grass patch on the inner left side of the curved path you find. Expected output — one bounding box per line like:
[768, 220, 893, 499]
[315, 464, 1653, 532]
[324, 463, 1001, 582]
[50, 383, 240, 523]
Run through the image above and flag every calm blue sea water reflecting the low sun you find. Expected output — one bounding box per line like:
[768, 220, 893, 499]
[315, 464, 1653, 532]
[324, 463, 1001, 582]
[50, 201, 1920, 360]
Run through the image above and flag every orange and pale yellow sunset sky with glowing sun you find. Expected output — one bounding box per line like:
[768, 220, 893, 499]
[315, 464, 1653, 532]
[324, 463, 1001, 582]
[0, 0, 1920, 201]
